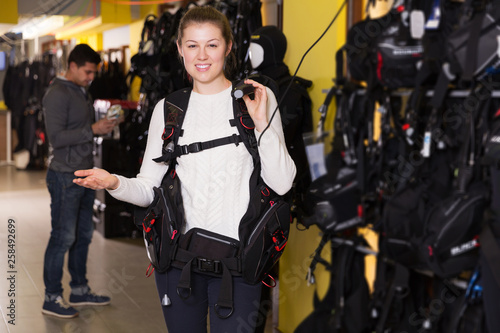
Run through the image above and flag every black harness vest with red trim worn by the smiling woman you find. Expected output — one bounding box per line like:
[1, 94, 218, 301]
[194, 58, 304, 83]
[136, 81, 290, 318]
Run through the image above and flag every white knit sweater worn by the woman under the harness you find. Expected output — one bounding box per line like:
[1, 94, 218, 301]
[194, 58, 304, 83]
[109, 87, 296, 239]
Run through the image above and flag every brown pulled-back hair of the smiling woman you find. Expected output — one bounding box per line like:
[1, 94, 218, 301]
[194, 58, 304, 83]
[177, 6, 236, 80]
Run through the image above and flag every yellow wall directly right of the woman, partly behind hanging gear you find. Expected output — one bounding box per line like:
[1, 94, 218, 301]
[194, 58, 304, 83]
[279, 0, 346, 333]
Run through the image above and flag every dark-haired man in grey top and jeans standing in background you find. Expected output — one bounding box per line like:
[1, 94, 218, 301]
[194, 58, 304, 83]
[42, 44, 116, 318]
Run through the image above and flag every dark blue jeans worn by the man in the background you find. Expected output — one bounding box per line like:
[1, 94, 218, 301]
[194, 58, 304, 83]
[43, 169, 95, 295]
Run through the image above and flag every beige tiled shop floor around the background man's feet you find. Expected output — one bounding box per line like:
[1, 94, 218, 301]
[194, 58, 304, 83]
[0, 166, 272, 333]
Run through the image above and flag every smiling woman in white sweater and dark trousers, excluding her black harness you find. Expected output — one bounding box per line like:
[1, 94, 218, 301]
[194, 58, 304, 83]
[75, 7, 296, 333]
